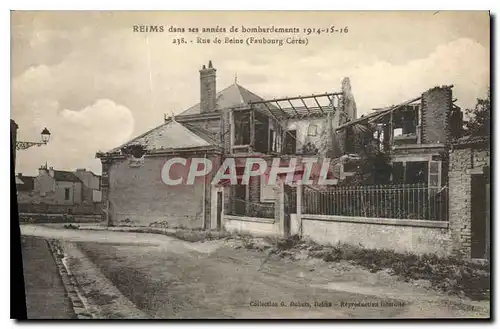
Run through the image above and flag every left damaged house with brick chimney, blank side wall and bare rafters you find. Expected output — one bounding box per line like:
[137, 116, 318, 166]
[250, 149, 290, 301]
[97, 62, 343, 228]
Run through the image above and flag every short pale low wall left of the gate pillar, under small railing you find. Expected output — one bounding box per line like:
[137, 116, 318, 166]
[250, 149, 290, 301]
[223, 215, 280, 236]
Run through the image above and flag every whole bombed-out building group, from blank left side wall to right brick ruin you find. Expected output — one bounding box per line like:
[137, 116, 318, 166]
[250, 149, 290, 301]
[97, 62, 468, 238]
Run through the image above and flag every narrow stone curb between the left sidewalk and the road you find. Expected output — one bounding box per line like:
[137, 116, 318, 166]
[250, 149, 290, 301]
[47, 240, 94, 319]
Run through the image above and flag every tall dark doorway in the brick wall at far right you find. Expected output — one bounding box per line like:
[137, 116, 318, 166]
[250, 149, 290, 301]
[471, 174, 488, 258]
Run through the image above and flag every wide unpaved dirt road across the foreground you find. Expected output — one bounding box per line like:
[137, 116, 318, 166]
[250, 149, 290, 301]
[21, 225, 489, 318]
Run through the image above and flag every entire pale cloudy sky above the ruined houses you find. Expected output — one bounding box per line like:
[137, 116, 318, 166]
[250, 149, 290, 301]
[11, 11, 490, 175]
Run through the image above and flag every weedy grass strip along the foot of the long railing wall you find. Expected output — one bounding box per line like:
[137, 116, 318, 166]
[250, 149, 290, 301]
[246, 236, 490, 300]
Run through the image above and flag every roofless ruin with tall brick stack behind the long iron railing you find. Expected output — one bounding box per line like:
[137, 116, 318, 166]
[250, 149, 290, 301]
[336, 86, 463, 187]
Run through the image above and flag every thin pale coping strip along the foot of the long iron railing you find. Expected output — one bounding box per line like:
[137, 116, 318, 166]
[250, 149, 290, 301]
[302, 214, 449, 228]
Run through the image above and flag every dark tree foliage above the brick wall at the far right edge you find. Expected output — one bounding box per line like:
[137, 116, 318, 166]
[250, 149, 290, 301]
[465, 88, 491, 137]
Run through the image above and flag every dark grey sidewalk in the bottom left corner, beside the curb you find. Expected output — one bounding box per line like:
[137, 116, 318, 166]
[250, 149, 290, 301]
[22, 236, 75, 320]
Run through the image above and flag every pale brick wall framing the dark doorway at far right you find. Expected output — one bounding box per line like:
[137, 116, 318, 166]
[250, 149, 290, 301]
[448, 148, 490, 258]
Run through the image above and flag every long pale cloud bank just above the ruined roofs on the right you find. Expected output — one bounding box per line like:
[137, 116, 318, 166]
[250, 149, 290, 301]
[237, 38, 490, 114]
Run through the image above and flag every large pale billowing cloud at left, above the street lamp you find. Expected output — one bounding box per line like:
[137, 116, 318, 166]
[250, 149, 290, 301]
[12, 66, 134, 174]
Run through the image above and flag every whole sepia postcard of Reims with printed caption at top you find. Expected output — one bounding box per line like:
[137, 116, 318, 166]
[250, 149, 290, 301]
[11, 11, 491, 319]
